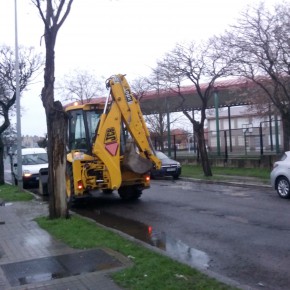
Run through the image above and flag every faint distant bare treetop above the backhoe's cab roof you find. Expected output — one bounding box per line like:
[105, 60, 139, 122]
[57, 69, 105, 104]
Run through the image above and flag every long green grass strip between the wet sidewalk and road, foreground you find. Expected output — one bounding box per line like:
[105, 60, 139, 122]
[36, 215, 236, 290]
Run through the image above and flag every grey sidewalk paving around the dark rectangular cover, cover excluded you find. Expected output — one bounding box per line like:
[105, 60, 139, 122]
[0, 200, 125, 290]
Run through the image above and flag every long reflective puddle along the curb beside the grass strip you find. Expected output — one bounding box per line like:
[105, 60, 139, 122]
[73, 208, 209, 269]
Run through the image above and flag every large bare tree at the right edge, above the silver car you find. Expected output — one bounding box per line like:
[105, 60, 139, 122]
[220, 2, 290, 151]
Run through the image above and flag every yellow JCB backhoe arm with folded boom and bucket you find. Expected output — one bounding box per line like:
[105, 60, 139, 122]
[93, 75, 161, 189]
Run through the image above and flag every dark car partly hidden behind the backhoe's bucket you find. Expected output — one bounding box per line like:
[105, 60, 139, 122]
[151, 151, 181, 179]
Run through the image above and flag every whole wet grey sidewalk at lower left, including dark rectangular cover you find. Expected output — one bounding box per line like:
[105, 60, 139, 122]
[0, 200, 129, 290]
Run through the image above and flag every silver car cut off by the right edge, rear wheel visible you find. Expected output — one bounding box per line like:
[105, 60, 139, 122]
[270, 151, 290, 198]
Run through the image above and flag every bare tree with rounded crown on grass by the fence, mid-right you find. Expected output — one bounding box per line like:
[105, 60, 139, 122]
[157, 42, 231, 176]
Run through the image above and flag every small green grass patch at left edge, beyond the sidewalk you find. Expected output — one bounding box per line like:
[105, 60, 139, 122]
[0, 184, 34, 202]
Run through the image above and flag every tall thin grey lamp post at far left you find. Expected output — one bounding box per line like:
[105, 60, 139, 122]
[14, 0, 23, 189]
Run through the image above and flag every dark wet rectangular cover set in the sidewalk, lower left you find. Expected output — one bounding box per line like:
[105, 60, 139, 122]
[1, 249, 122, 286]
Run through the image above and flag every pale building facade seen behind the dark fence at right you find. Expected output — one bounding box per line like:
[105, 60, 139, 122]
[207, 106, 283, 154]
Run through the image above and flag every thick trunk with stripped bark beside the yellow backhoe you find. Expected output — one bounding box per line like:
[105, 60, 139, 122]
[41, 40, 68, 219]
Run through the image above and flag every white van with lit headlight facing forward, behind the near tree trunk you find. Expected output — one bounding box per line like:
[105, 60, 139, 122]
[13, 148, 48, 185]
